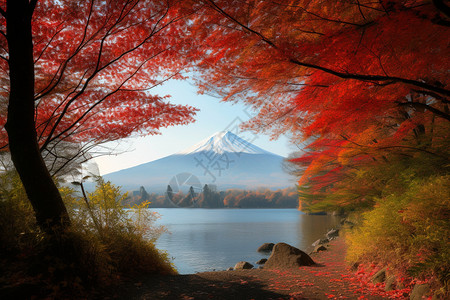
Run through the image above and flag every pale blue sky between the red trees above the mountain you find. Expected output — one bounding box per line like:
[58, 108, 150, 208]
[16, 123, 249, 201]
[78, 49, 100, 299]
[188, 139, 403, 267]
[95, 81, 294, 175]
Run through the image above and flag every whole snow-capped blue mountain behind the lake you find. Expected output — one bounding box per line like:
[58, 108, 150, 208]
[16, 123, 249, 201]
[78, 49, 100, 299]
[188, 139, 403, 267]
[104, 131, 295, 193]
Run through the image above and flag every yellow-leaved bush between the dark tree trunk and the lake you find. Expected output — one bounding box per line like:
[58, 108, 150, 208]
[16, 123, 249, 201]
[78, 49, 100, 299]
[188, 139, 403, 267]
[61, 178, 176, 274]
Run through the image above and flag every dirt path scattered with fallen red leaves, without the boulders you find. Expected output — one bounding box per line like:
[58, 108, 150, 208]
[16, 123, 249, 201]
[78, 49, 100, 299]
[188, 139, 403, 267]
[108, 238, 400, 300]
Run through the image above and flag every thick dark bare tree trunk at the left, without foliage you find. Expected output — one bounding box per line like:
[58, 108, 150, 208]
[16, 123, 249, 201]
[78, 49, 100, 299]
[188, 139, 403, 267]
[5, 0, 70, 235]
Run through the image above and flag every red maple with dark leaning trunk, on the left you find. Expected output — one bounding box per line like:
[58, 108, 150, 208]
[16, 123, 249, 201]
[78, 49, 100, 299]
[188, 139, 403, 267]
[0, 0, 196, 232]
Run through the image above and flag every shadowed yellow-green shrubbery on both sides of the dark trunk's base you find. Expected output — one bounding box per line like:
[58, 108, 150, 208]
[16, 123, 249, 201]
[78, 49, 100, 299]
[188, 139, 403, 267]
[0, 172, 176, 298]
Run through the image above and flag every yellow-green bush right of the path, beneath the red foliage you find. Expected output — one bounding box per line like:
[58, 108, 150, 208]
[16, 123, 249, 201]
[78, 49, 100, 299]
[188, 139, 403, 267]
[347, 175, 450, 288]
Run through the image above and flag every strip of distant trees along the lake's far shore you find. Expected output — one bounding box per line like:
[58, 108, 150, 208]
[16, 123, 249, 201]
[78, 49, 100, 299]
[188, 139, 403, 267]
[123, 184, 298, 208]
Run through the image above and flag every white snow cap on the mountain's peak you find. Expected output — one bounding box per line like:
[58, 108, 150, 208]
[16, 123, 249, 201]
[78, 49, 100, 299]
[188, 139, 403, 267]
[177, 131, 273, 154]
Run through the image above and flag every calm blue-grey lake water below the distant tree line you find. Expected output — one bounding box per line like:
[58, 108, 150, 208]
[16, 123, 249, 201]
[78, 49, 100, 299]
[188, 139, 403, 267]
[152, 208, 338, 274]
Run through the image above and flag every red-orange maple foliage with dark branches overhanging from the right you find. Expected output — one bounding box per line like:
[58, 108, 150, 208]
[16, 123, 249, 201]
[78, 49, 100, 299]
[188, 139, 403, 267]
[193, 0, 450, 209]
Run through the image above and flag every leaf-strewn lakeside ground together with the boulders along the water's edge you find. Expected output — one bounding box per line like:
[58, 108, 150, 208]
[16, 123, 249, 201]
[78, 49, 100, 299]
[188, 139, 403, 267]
[103, 230, 420, 300]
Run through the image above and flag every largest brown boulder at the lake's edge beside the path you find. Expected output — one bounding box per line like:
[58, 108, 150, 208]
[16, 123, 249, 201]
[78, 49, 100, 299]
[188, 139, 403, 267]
[264, 243, 315, 270]
